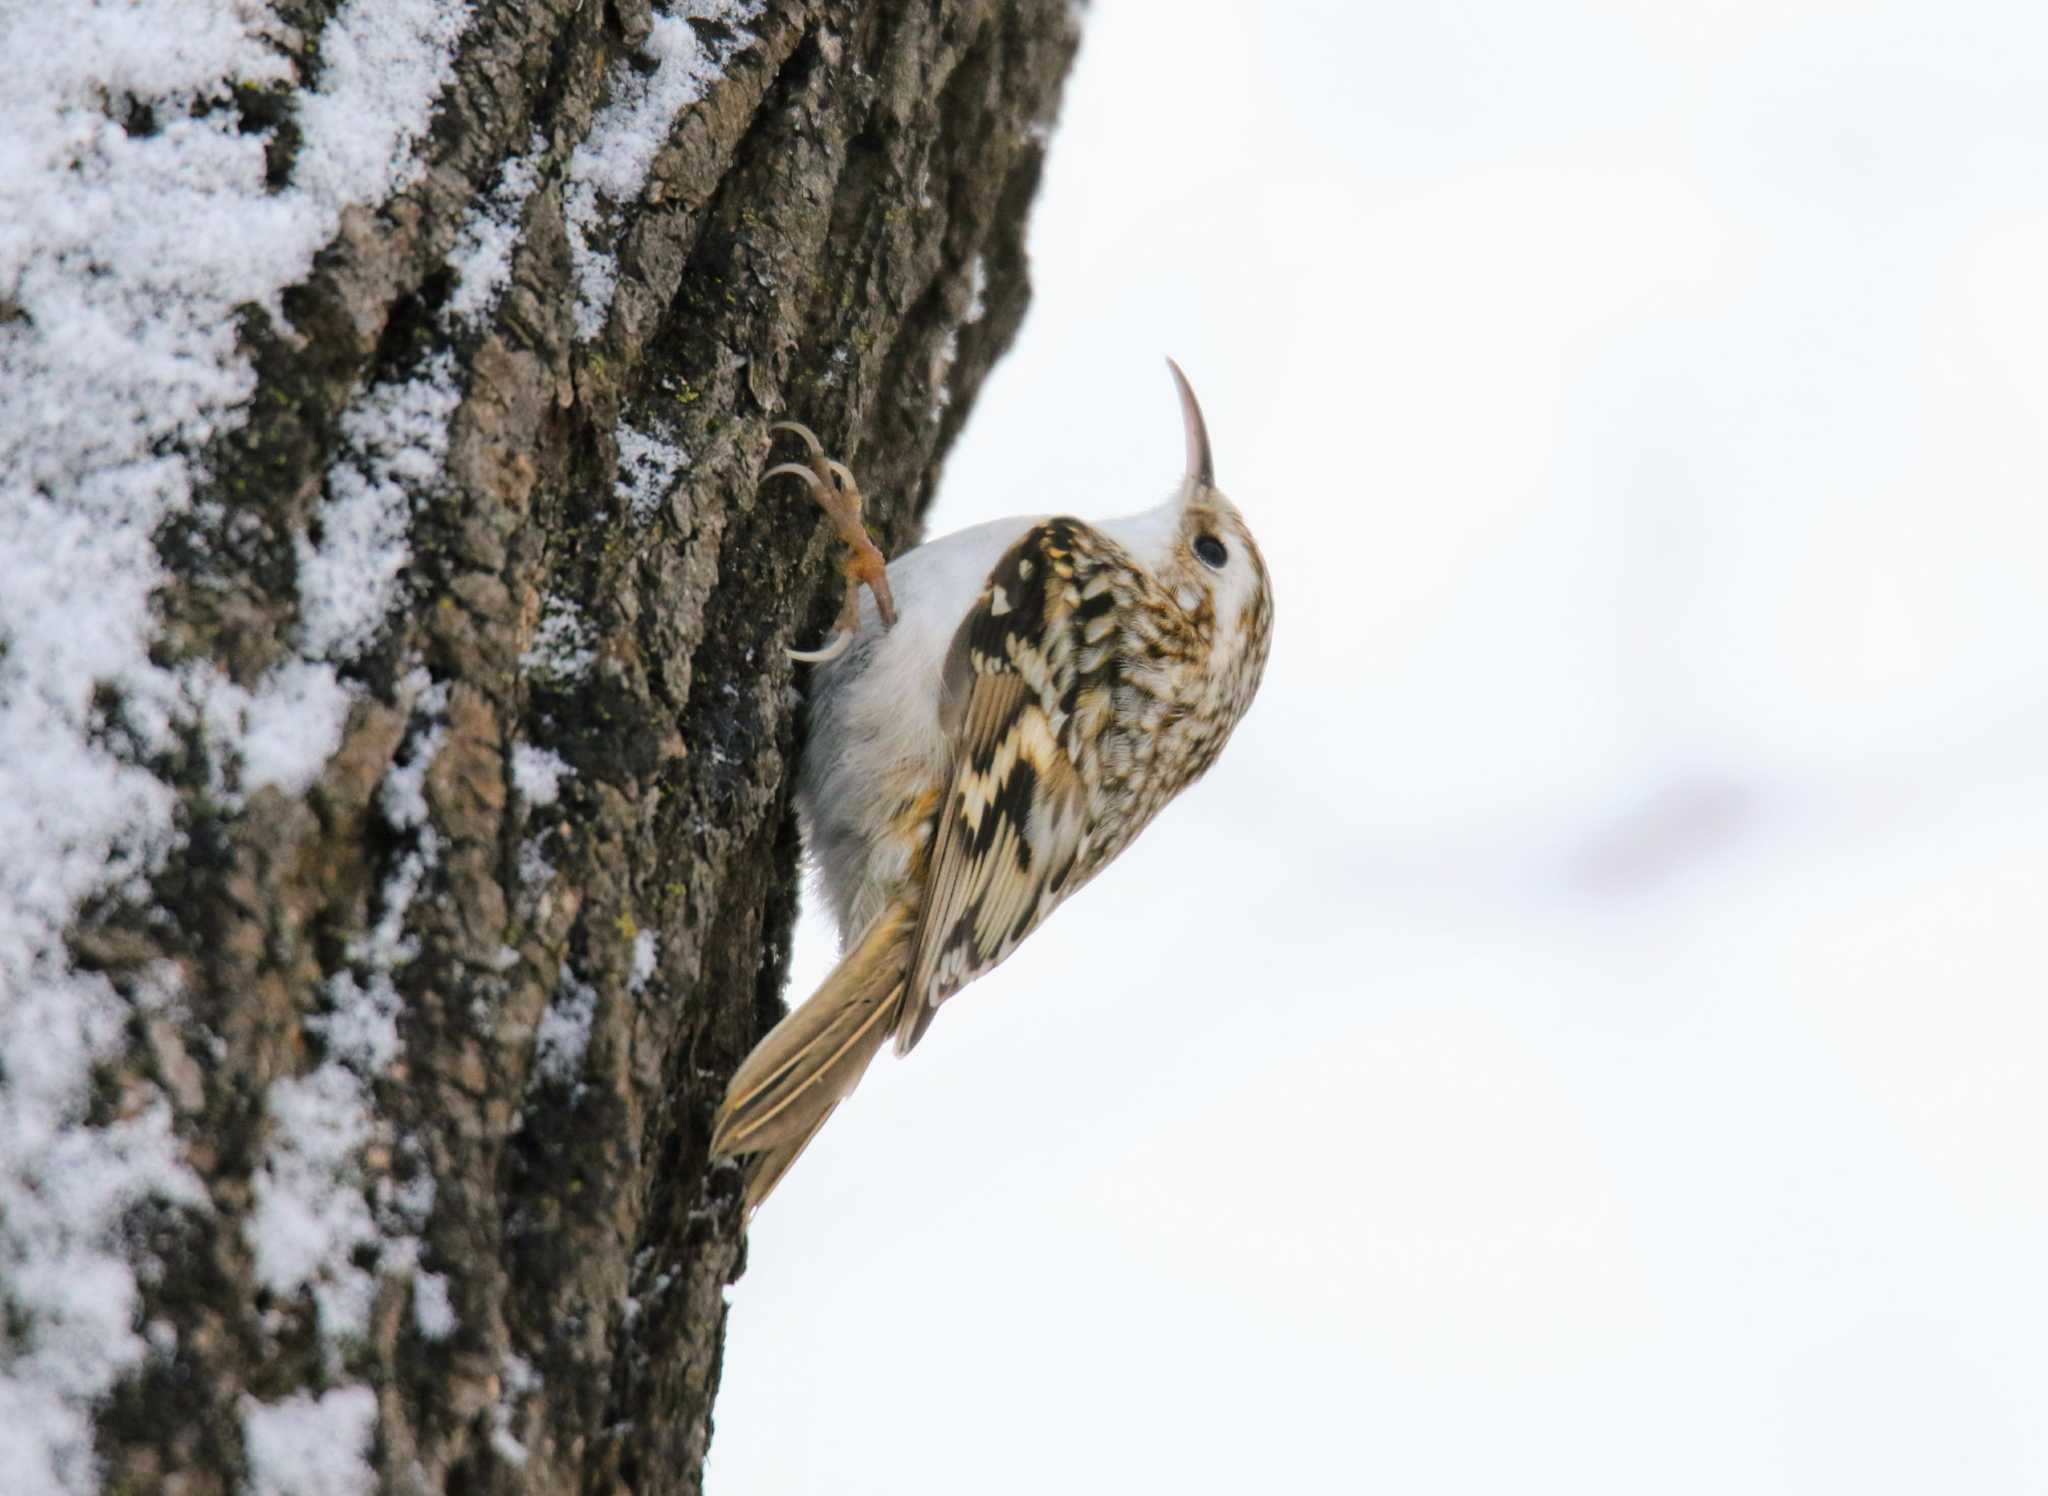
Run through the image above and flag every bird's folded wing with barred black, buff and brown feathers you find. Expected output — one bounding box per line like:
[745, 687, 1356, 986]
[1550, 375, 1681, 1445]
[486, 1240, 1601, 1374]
[897, 518, 1114, 1053]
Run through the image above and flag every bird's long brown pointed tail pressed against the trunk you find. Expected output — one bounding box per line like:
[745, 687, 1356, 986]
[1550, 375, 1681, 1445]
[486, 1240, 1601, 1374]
[711, 904, 915, 1215]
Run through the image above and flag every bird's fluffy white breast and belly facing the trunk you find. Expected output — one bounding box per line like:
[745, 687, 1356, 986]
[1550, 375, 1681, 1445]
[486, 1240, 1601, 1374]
[797, 514, 1044, 941]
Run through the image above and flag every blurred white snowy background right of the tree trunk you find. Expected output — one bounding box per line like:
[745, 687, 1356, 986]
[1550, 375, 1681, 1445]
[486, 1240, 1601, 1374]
[709, 0, 2048, 1496]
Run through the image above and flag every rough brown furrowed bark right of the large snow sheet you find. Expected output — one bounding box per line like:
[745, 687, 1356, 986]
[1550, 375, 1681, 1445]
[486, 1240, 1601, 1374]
[0, 0, 1075, 1492]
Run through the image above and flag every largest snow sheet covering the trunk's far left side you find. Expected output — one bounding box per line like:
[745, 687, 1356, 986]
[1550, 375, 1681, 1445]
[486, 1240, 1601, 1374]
[0, 0, 469, 1492]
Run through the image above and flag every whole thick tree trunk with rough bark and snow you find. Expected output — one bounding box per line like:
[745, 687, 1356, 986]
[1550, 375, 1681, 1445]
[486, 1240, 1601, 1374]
[0, 0, 1075, 1492]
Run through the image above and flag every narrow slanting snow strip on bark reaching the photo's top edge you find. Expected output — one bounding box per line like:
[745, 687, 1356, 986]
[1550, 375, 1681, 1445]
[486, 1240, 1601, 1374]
[563, 0, 762, 338]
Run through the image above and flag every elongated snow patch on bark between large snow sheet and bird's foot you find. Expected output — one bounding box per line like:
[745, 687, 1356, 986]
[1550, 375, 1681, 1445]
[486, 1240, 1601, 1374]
[299, 352, 463, 660]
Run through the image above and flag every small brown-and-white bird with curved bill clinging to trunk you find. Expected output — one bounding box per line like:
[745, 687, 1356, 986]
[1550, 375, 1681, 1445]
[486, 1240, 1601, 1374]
[709, 359, 1272, 1217]
